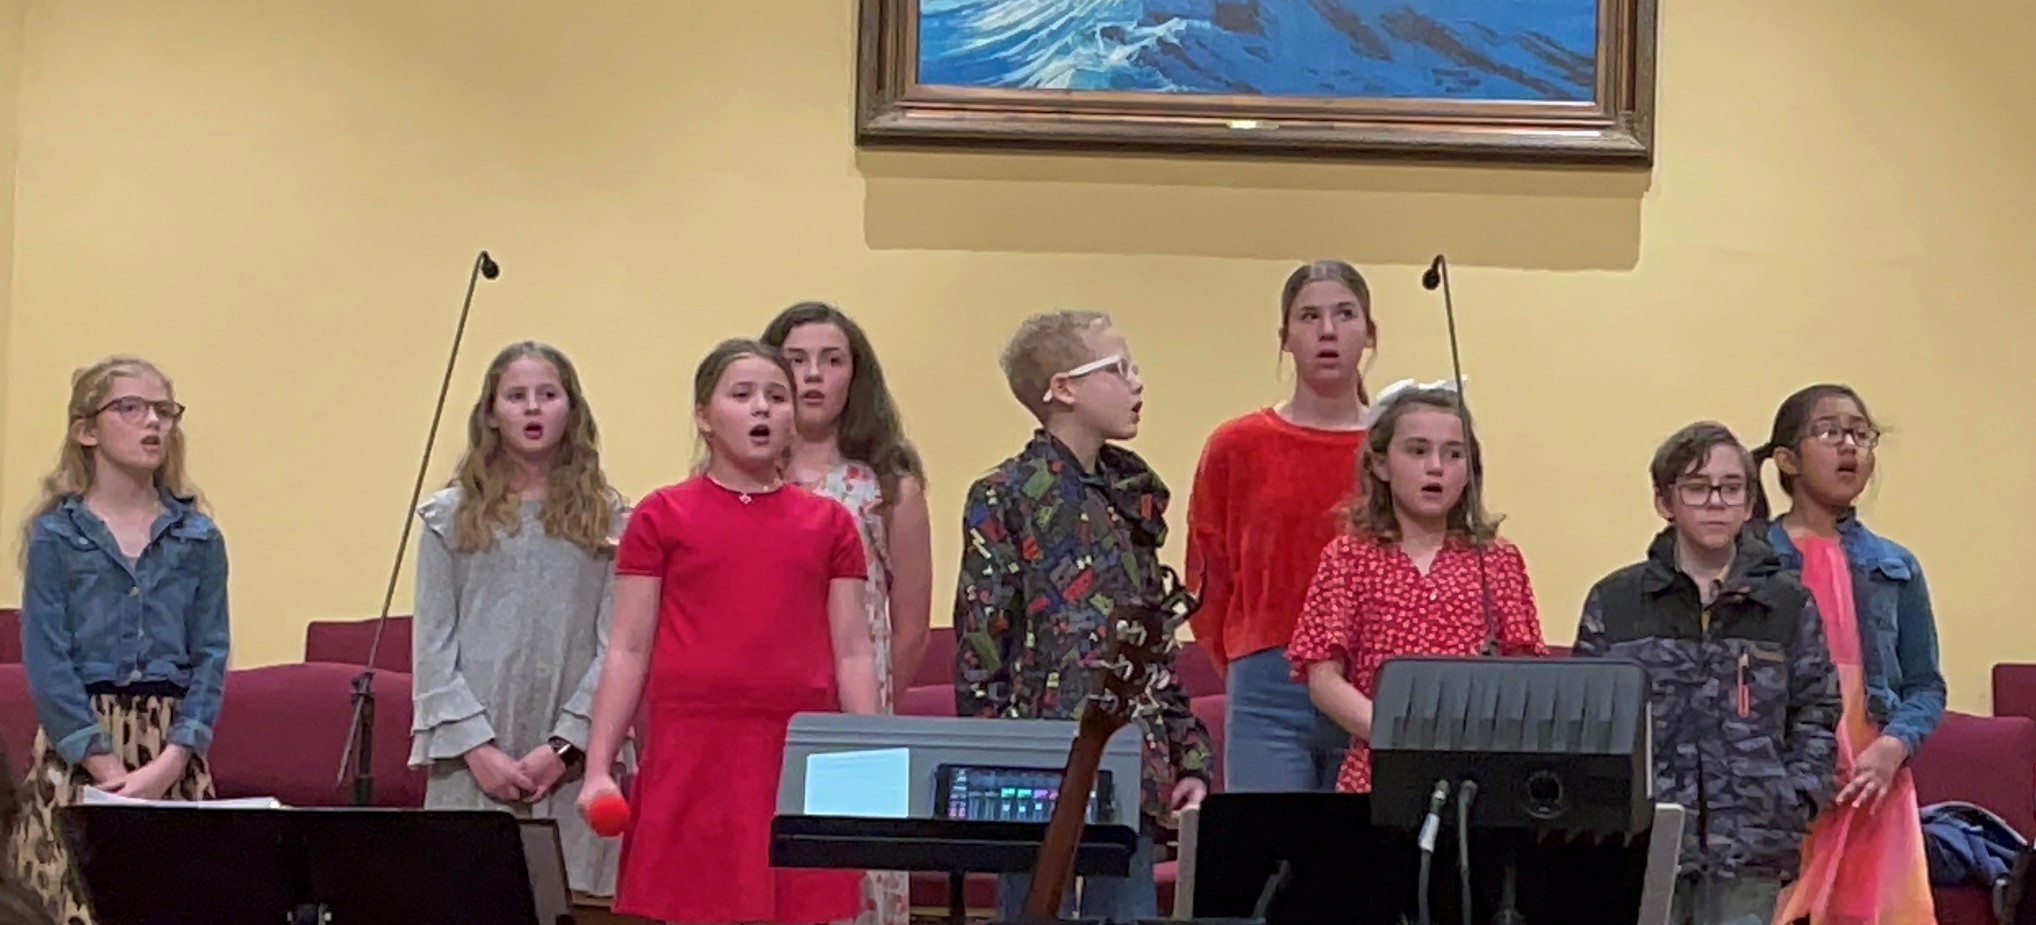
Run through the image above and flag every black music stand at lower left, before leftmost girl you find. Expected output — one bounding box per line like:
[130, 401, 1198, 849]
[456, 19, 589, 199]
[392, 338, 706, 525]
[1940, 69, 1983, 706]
[57, 805, 572, 925]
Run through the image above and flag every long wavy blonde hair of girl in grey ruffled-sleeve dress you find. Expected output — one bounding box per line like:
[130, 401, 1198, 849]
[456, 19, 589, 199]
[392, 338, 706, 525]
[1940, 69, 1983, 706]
[452, 340, 623, 556]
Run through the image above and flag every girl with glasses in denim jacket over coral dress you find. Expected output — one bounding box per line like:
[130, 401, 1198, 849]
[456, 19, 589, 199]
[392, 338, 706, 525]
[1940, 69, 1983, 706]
[1755, 385, 1944, 925]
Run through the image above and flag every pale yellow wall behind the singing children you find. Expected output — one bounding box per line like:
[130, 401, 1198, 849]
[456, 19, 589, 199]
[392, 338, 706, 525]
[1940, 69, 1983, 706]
[0, 0, 2036, 709]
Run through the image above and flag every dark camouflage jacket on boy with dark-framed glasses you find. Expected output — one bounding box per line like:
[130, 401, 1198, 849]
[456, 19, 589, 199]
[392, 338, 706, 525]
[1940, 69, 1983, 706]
[1574, 530, 1843, 880]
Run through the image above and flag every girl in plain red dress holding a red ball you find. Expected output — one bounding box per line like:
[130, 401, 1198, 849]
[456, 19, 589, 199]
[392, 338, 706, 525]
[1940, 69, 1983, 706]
[580, 340, 878, 925]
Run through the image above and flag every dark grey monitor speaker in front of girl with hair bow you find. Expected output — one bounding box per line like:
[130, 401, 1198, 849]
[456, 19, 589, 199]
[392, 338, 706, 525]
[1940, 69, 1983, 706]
[1370, 658, 1655, 839]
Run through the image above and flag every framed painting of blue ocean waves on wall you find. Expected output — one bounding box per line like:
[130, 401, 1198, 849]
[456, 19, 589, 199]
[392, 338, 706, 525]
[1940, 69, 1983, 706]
[857, 0, 1657, 167]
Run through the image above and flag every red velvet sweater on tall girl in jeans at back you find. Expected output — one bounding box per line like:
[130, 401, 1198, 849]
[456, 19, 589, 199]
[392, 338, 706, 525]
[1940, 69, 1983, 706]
[1185, 407, 1364, 672]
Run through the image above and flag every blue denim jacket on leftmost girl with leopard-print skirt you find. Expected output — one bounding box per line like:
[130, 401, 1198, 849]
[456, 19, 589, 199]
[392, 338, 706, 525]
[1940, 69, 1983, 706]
[20, 491, 228, 764]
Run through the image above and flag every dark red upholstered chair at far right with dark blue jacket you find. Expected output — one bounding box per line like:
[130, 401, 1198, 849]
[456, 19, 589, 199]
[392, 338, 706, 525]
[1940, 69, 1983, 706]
[1912, 713, 2036, 925]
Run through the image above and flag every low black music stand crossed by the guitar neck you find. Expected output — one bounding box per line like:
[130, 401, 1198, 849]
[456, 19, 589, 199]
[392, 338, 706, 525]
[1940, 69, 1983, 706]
[770, 815, 1138, 925]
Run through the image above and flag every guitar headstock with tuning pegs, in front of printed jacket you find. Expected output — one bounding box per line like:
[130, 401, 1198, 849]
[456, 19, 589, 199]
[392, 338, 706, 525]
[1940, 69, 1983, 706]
[1081, 566, 1201, 740]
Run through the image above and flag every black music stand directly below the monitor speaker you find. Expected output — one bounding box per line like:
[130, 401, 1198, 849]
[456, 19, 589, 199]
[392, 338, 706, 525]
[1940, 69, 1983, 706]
[1175, 793, 1684, 925]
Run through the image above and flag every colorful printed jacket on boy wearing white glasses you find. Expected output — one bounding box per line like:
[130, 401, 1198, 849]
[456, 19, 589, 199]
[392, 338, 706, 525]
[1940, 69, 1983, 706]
[955, 432, 1209, 825]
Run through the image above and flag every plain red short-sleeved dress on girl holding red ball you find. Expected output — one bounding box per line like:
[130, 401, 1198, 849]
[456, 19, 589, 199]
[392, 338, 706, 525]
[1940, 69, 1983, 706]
[615, 477, 867, 923]
